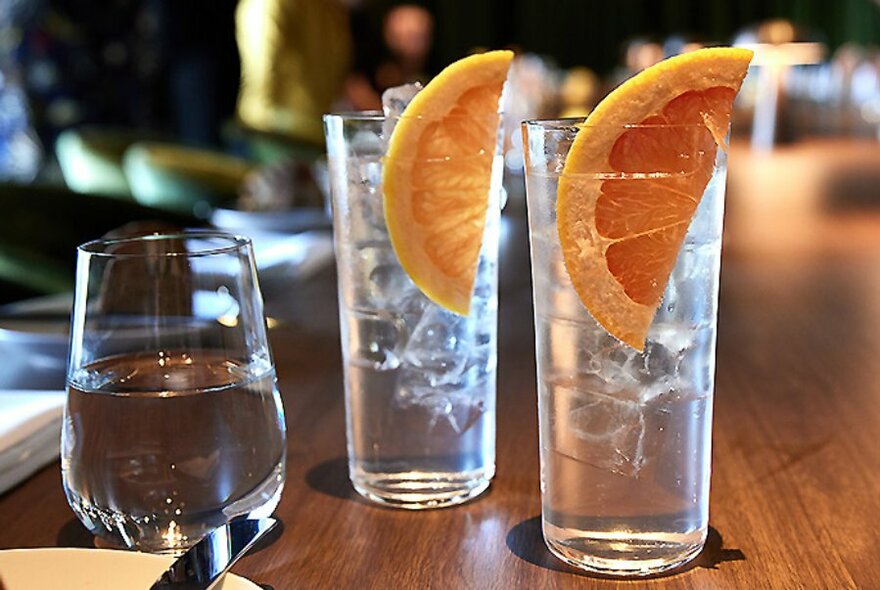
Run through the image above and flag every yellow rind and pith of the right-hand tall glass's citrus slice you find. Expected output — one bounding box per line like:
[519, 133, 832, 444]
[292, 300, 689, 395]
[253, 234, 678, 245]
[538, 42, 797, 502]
[556, 48, 752, 351]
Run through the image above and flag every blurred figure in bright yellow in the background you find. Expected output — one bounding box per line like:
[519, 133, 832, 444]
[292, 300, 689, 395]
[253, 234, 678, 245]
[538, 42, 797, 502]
[236, 0, 352, 146]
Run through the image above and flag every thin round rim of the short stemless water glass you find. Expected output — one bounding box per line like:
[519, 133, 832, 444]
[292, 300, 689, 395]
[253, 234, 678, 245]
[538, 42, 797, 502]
[76, 230, 252, 258]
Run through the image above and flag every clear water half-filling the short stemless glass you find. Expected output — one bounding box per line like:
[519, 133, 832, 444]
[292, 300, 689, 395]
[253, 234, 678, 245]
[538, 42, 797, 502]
[62, 350, 285, 553]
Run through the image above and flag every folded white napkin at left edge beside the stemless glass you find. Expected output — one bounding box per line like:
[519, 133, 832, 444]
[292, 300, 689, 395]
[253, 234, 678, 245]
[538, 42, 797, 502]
[0, 390, 66, 494]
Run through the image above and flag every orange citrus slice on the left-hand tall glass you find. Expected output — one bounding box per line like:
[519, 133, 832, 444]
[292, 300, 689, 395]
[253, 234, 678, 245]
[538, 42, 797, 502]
[382, 51, 513, 315]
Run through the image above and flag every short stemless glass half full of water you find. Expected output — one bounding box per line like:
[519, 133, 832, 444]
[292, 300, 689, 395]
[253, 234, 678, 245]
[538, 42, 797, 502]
[61, 232, 286, 553]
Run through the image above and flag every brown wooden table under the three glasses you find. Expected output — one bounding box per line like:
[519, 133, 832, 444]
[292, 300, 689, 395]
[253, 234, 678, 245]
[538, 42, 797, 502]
[0, 143, 880, 590]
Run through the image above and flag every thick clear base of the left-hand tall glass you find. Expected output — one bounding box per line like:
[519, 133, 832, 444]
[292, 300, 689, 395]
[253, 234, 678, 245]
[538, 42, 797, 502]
[351, 470, 494, 510]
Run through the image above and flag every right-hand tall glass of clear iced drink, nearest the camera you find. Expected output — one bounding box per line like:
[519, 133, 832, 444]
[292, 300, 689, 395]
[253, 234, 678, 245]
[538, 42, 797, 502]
[523, 120, 726, 575]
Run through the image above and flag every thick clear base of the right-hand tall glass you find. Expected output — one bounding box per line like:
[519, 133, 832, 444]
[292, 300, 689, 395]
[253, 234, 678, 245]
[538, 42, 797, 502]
[544, 531, 706, 577]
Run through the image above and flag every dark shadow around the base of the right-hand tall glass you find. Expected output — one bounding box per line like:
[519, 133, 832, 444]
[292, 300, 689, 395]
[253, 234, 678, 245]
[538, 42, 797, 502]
[507, 515, 746, 581]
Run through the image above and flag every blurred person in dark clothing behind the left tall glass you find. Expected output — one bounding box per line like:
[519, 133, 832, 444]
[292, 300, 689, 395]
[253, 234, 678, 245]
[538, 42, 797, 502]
[375, 4, 434, 92]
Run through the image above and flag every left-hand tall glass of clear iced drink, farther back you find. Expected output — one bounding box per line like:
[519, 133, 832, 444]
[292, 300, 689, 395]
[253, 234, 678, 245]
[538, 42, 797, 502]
[324, 113, 502, 509]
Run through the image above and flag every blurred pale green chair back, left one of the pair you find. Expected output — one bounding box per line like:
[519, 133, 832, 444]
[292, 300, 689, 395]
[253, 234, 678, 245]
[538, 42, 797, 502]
[55, 127, 159, 199]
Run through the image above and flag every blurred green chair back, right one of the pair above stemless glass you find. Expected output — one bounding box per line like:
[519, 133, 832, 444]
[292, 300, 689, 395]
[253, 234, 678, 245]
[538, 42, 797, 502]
[123, 142, 254, 218]
